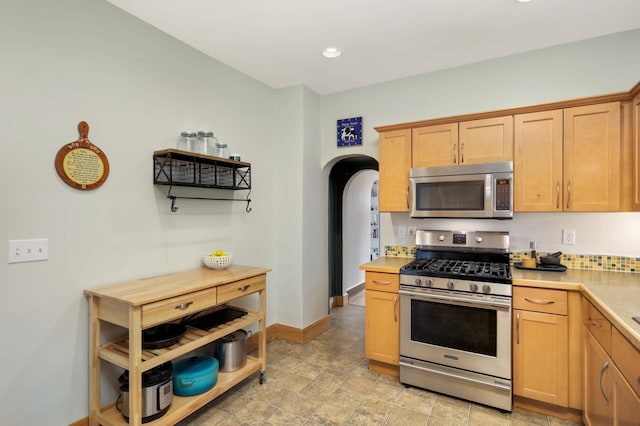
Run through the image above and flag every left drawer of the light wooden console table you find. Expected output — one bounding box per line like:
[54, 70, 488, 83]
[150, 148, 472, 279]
[142, 288, 217, 329]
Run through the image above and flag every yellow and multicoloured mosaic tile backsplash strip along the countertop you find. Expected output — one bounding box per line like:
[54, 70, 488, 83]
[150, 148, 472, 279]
[384, 246, 640, 274]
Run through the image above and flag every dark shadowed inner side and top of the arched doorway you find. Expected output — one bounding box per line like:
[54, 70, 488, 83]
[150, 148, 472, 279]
[329, 155, 378, 298]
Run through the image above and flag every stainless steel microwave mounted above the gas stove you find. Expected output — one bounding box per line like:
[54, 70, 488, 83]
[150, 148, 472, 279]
[409, 161, 513, 219]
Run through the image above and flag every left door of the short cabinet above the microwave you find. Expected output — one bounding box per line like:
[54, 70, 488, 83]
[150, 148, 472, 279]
[411, 123, 458, 167]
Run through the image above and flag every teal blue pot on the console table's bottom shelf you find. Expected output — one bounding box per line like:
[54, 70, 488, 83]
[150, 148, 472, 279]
[173, 355, 219, 396]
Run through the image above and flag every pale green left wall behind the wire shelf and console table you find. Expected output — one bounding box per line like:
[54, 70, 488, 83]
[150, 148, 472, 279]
[0, 0, 282, 426]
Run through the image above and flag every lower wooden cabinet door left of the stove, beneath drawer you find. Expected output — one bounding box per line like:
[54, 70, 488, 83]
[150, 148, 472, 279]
[364, 290, 400, 365]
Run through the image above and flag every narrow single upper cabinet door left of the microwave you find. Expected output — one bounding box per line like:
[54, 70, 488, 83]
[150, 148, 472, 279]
[378, 130, 411, 212]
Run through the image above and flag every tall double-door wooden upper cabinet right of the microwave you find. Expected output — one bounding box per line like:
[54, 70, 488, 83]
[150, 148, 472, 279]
[514, 102, 622, 212]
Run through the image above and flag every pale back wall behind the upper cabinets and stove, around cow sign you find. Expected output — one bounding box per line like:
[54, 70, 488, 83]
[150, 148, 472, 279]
[322, 30, 640, 256]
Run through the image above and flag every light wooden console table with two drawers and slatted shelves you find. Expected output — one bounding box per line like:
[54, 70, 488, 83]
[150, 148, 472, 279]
[85, 265, 271, 425]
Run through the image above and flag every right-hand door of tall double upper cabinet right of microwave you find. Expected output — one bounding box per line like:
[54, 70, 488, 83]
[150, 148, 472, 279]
[564, 102, 621, 211]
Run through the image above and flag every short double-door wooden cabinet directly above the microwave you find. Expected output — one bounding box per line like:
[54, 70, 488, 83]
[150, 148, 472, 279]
[412, 115, 513, 167]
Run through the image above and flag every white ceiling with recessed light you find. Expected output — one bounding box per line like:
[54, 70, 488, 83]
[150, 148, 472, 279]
[107, 0, 640, 95]
